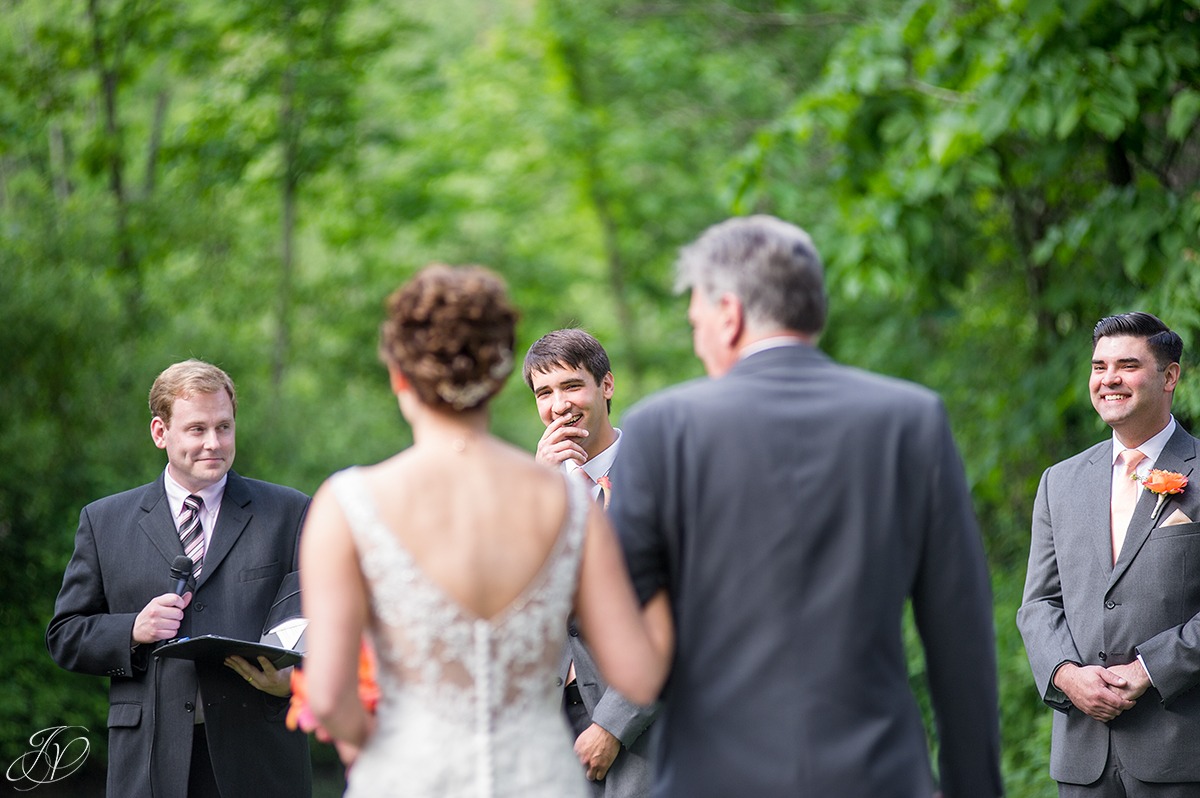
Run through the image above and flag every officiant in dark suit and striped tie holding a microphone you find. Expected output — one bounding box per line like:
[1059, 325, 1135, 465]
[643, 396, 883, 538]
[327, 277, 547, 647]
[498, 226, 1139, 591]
[46, 360, 312, 798]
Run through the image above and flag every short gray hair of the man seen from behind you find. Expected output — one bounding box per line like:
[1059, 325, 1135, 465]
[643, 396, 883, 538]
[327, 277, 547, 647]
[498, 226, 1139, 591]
[676, 215, 826, 335]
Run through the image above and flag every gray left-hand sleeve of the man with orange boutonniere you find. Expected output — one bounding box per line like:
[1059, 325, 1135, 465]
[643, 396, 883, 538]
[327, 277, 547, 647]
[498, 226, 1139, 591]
[1016, 469, 1082, 712]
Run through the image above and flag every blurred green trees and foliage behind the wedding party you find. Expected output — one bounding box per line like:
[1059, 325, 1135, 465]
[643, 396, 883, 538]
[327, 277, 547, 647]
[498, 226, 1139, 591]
[0, 0, 1200, 797]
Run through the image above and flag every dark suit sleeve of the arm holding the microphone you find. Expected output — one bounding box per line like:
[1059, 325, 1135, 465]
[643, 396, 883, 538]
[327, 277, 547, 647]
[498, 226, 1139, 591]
[46, 508, 145, 676]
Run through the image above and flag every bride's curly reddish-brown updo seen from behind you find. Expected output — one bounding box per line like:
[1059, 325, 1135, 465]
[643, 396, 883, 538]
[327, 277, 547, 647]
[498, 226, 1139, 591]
[379, 263, 517, 412]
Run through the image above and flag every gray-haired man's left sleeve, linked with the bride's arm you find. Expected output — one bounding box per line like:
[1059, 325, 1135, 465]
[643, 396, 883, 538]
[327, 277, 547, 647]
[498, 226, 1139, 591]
[608, 410, 670, 604]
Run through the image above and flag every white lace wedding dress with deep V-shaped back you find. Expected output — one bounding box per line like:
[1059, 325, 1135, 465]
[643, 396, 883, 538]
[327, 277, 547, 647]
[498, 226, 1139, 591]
[331, 468, 589, 798]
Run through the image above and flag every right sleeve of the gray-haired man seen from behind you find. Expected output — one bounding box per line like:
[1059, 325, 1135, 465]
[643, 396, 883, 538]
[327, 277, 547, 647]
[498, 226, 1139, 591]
[912, 403, 1003, 798]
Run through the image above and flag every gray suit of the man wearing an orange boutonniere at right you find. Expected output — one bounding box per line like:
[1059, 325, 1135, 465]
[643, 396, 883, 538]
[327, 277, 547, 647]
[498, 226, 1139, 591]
[1016, 427, 1200, 784]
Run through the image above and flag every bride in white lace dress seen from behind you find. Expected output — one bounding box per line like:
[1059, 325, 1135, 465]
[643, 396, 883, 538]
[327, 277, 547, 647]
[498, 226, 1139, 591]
[300, 265, 673, 796]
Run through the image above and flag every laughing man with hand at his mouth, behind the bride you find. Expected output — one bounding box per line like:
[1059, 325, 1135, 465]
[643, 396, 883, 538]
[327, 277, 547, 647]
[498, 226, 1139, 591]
[523, 329, 658, 798]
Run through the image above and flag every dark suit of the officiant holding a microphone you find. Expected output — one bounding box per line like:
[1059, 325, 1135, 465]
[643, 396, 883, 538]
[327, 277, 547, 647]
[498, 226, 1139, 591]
[46, 472, 312, 798]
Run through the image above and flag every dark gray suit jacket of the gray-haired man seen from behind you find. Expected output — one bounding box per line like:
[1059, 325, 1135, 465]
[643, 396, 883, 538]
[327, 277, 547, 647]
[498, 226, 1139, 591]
[611, 346, 1002, 798]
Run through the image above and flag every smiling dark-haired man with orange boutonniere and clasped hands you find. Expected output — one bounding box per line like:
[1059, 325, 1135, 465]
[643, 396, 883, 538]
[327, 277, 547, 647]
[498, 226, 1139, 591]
[1016, 313, 1200, 798]
